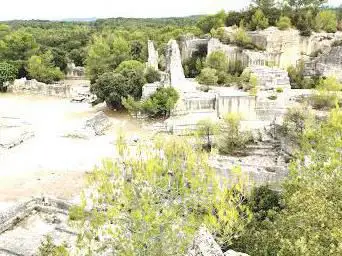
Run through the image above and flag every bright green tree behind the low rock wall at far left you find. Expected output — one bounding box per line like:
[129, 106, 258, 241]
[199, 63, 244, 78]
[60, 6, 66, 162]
[27, 51, 64, 83]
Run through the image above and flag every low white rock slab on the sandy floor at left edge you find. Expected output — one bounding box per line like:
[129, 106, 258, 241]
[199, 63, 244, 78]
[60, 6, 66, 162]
[0, 117, 34, 149]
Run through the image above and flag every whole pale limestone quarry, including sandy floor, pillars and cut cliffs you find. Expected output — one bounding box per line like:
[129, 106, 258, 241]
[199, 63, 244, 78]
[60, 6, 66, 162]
[0, 23, 342, 256]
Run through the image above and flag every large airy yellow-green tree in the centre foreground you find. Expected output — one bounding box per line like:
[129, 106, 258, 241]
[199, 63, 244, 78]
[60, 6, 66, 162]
[67, 136, 251, 256]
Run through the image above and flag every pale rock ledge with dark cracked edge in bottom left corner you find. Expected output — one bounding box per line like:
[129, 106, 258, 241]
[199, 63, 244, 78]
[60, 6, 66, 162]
[0, 198, 77, 256]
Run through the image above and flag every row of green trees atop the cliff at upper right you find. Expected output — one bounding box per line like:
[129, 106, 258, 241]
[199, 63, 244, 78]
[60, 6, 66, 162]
[198, 0, 342, 36]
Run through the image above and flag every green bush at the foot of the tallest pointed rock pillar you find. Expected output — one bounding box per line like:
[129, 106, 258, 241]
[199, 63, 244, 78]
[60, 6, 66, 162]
[142, 87, 179, 118]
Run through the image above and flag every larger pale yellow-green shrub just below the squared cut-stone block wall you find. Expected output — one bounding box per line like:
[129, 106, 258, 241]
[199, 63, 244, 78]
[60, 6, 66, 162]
[218, 114, 253, 155]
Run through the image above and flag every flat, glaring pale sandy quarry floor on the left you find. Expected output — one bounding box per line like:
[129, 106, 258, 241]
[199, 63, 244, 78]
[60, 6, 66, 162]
[0, 94, 141, 207]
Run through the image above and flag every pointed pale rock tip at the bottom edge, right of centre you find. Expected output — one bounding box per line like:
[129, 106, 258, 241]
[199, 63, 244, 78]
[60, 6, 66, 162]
[187, 227, 248, 256]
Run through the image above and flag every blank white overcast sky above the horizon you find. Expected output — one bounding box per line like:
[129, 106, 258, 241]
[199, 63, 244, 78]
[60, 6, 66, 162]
[0, 0, 342, 20]
